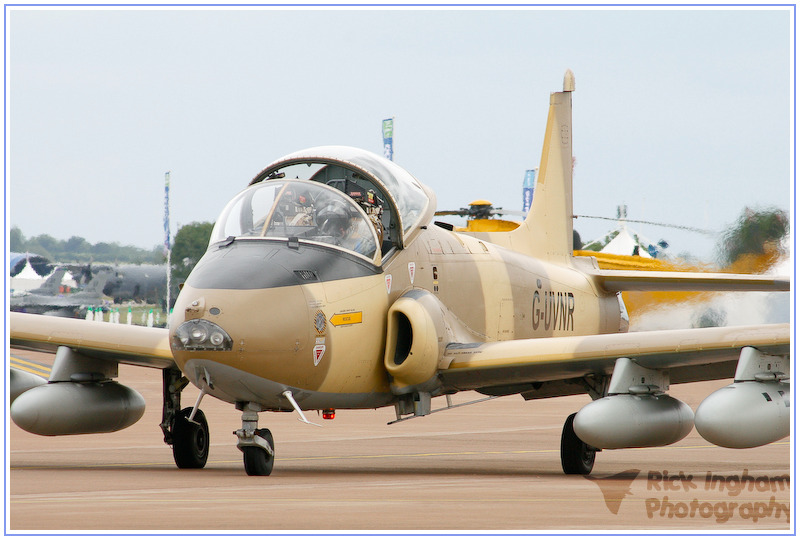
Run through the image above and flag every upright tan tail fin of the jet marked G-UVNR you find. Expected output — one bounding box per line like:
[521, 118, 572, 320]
[510, 70, 575, 260]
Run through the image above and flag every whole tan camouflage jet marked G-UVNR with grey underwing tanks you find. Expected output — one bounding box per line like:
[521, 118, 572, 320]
[10, 72, 790, 476]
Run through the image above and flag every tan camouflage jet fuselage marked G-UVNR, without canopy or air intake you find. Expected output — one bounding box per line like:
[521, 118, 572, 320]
[170, 221, 620, 410]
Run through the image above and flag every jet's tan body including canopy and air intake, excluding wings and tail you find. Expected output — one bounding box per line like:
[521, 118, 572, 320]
[170, 147, 621, 410]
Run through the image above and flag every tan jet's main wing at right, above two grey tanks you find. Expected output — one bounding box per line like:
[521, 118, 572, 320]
[439, 324, 790, 399]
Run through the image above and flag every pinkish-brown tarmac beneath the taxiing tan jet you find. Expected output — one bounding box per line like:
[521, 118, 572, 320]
[6, 350, 794, 534]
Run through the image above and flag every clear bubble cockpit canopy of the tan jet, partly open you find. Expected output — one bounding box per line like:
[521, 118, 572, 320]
[210, 146, 435, 263]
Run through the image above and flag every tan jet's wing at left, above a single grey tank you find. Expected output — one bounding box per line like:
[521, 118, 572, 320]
[9, 312, 176, 369]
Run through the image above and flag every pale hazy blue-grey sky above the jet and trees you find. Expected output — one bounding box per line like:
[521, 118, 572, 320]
[6, 7, 794, 257]
